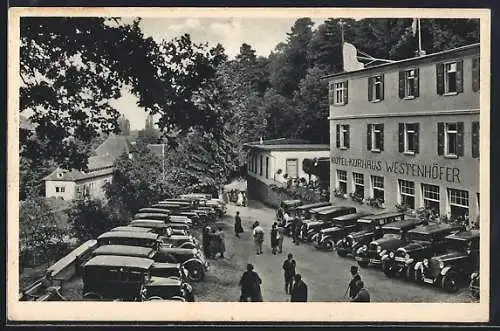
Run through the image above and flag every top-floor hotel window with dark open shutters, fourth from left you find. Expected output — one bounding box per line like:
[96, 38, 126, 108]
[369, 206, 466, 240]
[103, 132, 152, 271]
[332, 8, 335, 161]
[436, 61, 463, 95]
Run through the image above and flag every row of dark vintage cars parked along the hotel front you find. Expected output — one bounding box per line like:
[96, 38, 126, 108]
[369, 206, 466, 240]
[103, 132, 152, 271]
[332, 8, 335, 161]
[281, 200, 479, 297]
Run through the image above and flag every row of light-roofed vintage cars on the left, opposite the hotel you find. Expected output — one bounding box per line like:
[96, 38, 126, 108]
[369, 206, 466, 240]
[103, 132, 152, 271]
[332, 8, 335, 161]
[81, 194, 225, 301]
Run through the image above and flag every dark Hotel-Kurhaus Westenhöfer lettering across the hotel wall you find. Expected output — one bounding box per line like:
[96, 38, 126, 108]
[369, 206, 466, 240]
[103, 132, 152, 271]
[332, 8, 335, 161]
[331, 156, 460, 183]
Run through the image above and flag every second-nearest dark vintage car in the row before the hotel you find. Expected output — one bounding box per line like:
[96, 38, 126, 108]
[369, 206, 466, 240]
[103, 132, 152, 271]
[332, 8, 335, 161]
[382, 223, 465, 280]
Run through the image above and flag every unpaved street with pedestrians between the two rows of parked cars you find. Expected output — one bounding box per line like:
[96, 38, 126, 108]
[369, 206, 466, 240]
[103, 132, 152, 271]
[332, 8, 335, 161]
[193, 201, 473, 302]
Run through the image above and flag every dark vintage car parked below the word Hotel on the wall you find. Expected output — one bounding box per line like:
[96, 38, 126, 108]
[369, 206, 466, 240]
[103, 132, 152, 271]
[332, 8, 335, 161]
[312, 212, 373, 250]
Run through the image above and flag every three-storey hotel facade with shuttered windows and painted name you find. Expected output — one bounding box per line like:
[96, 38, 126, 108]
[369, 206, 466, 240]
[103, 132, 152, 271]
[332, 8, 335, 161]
[325, 44, 480, 221]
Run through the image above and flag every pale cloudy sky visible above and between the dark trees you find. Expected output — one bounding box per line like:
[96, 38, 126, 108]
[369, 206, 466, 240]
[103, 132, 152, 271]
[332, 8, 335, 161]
[111, 17, 326, 130]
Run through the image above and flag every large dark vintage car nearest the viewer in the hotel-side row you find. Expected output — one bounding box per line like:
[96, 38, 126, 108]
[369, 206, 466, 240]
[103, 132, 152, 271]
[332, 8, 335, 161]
[415, 230, 479, 293]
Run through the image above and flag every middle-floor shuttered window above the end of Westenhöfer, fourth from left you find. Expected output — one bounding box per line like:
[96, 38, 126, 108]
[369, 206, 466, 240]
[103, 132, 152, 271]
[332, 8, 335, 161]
[438, 122, 464, 158]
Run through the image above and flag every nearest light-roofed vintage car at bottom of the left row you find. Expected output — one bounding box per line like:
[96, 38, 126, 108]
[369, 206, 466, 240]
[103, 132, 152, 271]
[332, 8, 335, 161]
[82, 255, 194, 301]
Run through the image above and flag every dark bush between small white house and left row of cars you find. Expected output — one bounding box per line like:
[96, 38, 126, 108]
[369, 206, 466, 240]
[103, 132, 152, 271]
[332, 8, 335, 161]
[67, 199, 127, 242]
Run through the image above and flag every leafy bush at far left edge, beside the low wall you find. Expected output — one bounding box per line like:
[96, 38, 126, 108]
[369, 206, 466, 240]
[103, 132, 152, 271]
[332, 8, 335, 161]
[19, 197, 66, 265]
